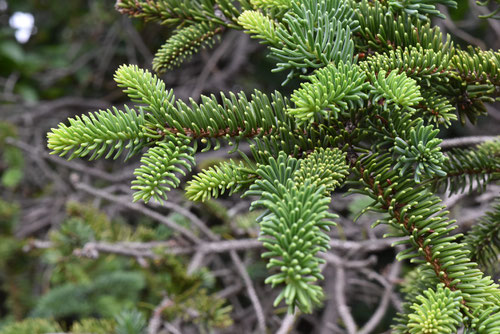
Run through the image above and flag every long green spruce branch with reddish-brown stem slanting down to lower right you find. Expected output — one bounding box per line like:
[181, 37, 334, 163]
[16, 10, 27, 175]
[353, 154, 499, 314]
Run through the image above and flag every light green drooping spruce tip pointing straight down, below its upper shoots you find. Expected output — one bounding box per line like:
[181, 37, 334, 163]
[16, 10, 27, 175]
[259, 183, 336, 313]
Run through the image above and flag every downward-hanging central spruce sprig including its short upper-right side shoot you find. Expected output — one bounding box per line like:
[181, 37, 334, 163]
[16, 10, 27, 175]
[245, 149, 347, 313]
